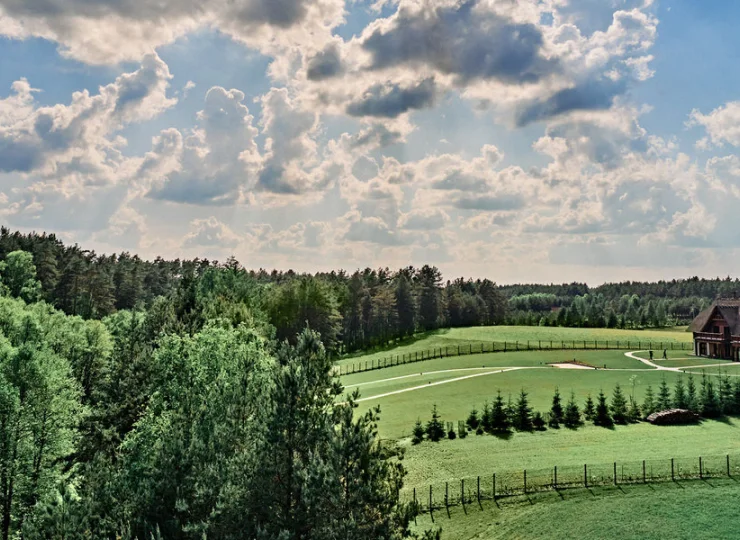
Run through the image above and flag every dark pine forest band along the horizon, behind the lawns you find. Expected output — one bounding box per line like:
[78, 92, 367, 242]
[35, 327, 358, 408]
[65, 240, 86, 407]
[0, 227, 728, 353]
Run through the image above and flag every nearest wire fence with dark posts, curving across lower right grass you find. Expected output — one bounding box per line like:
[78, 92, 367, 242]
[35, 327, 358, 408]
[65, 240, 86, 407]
[401, 454, 740, 514]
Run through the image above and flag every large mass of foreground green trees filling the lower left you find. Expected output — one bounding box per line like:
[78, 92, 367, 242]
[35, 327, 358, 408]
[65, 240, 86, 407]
[0, 292, 446, 540]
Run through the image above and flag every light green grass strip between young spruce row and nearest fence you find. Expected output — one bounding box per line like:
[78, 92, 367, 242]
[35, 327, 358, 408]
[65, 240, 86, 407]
[403, 419, 740, 491]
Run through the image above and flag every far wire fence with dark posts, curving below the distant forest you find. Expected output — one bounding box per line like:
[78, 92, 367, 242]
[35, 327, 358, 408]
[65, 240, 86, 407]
[338, 340, 694, 375]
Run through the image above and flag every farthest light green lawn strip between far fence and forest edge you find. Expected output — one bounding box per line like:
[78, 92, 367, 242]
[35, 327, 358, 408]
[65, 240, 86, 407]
[337, 326, 692, 366]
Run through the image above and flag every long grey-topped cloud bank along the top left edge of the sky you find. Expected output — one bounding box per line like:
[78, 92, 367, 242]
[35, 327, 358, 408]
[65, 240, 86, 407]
[0, 0, 344, 64]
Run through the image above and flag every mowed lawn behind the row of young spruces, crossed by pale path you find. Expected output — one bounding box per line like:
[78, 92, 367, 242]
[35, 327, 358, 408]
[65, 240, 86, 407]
[352, 351, 679, 439]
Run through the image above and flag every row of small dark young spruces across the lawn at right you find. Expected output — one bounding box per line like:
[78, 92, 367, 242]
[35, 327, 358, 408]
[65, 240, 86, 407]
[412, 373, 740, 444]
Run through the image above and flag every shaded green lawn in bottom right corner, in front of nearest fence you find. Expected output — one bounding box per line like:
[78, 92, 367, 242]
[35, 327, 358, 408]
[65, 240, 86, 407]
[416, 479, 740, 540]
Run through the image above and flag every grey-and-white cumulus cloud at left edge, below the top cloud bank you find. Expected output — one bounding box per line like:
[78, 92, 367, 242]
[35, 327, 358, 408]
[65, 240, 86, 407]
[0, 54, 176, 177]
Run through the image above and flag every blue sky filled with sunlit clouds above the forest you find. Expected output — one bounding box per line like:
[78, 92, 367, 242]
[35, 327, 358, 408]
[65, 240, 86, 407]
[0, 0, 740, 285]
